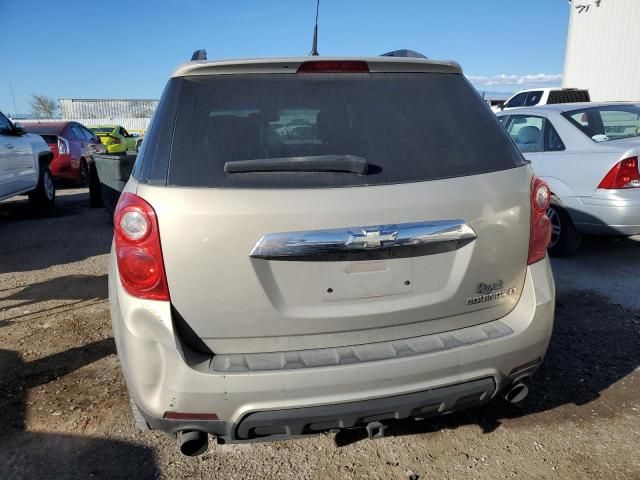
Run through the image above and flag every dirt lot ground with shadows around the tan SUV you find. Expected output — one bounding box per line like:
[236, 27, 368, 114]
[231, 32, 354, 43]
[0, 189, 640, 480]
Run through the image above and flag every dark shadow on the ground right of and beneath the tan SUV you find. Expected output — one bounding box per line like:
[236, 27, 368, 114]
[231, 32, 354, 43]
[335, 292, 640, 446]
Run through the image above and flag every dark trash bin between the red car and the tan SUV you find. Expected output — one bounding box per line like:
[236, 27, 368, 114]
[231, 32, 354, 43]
[93, 153, 136, 214]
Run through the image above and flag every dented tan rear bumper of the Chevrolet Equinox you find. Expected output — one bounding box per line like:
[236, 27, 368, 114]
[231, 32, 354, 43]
[109, 257, 555, 441]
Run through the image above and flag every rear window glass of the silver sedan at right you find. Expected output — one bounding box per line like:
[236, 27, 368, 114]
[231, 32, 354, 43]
[563, 105, 640, 142]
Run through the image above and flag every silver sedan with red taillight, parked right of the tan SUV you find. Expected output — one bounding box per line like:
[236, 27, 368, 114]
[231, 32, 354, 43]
[498, 103, 640, 255]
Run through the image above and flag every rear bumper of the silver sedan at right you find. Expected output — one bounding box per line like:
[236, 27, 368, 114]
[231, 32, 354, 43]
[563, 188, 640, 236]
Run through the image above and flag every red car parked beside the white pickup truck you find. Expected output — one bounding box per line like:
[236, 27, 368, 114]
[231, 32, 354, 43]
[22, 121, 106, 185]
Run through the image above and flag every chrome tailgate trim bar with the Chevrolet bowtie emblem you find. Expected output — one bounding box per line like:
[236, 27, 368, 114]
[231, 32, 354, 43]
[249, 219, 477, 261]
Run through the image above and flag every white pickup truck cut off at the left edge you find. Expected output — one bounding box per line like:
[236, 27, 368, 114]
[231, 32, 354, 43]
[0, 112, 56, 209]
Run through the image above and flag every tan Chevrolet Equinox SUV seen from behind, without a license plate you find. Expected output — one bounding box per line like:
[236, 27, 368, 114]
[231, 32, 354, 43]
[109, 57, 555, 455]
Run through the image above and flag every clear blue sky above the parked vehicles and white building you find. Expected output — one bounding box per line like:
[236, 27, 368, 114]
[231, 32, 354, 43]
[0, 0, 569, 113]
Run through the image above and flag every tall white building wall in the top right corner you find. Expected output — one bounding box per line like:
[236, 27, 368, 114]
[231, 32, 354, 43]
[562, 0, 640, 102]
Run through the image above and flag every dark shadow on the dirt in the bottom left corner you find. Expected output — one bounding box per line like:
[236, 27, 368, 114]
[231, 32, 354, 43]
[0, 344, 159, 479]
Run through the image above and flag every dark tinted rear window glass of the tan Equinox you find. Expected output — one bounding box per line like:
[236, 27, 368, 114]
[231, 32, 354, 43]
[166, 73, 522, 188]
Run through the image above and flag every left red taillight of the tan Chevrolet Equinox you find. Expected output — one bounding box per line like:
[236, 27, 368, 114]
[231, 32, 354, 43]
[113, 193, 169, 300]
